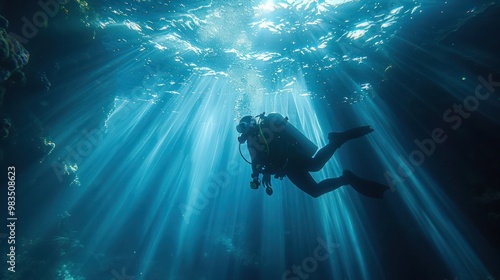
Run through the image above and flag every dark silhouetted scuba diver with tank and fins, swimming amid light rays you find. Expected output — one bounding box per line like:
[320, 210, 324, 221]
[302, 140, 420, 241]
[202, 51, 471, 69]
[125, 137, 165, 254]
[236, 113, 389, 198]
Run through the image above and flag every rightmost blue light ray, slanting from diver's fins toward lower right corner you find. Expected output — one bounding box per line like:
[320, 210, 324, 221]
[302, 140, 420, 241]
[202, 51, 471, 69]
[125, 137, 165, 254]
[357, 95, 488, 278]
